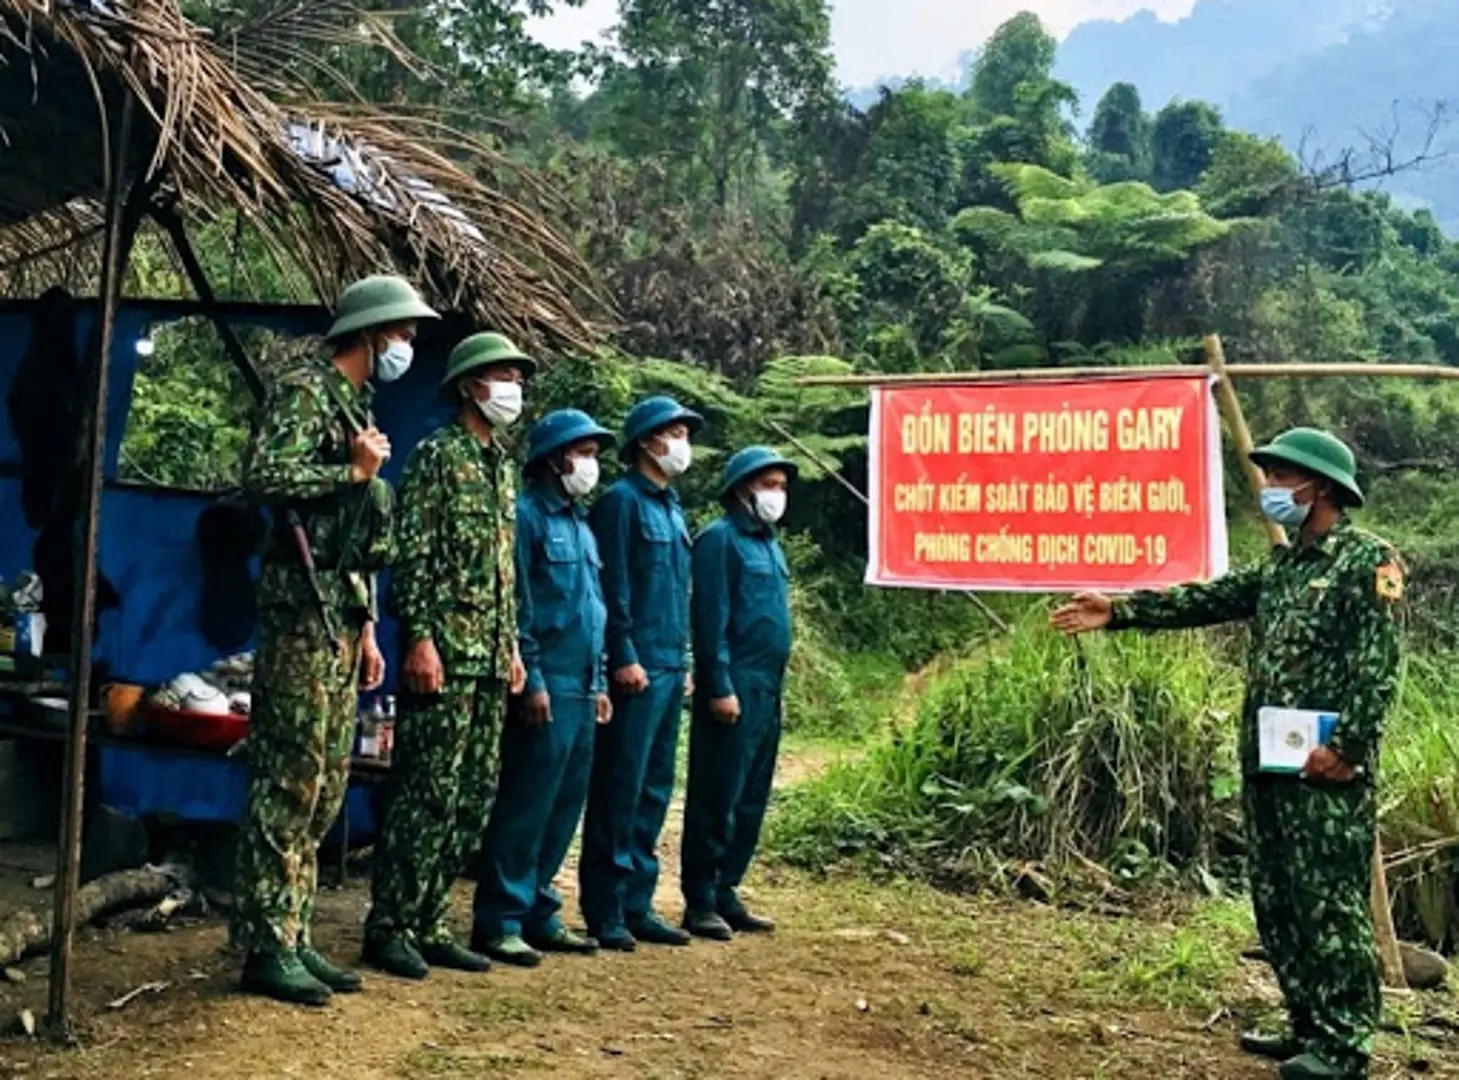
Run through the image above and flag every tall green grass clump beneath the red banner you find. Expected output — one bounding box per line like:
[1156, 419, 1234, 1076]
[769, 613, 1240, 884]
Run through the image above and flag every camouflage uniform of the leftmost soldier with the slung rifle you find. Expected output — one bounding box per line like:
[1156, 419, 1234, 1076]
[232, 360, 391, 953]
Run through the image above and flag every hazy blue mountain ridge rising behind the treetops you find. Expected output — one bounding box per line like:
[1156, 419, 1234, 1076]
[848, 0, 1459, 226]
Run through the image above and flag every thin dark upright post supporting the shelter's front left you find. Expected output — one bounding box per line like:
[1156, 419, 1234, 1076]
[47, 93, 140, 1036]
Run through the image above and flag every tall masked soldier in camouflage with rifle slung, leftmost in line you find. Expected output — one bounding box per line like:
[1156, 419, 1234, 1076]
[232, 277, 436, 1006]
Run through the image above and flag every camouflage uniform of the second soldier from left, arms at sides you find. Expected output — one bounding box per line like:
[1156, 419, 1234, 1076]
[366, 423, 516, 944]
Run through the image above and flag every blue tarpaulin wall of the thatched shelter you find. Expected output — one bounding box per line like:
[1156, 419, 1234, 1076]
[0, 301, 461, 833]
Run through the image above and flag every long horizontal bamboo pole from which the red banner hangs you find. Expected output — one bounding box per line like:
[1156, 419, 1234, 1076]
[795, 362, 1459, 387]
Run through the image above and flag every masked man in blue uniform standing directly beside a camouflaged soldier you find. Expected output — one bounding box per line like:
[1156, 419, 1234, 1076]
[471, 409, 613, 968]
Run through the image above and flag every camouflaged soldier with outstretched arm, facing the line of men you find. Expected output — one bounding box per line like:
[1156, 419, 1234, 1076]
[1053, 428, 1404, 1077]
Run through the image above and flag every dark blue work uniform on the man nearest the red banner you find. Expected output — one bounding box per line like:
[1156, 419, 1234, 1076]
[681, 508, 791, 912]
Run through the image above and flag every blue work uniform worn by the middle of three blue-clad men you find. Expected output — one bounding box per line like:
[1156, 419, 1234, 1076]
[579, 470, 690, 936]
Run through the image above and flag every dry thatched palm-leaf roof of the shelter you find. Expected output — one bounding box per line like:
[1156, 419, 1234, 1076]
[0, 0, 595, 347]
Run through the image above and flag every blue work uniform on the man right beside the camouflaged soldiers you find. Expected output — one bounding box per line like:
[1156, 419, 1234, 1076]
[473, 483, 607, 941]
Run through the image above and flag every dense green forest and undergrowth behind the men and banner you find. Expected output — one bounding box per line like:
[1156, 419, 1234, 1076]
[124, 0, 1459, 941]
